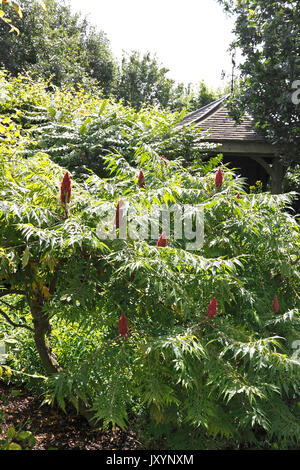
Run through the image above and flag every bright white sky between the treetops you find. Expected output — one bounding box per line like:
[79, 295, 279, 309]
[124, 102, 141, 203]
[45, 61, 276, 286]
[70, 0, 237, 88]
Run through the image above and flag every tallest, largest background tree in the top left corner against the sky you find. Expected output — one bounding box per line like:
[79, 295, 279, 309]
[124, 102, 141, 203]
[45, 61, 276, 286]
[0, 0, 115, 95]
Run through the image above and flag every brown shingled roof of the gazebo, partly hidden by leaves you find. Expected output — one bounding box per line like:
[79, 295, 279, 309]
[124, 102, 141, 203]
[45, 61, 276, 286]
[180, 95, 266, 142]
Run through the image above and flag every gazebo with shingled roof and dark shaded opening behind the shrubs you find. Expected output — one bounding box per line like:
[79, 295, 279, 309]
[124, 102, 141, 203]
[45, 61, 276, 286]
[179, 95, 283, 194]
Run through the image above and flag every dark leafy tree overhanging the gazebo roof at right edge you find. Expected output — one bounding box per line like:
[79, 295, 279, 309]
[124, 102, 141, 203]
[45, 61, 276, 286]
[219, 0, 300, 163]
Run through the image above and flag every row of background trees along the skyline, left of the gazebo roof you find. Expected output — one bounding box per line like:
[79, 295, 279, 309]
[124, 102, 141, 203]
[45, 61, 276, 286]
[0, 0, 221, 111]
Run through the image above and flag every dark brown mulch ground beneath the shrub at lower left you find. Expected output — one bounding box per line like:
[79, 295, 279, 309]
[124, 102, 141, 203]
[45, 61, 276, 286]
[0, 381, 142, 451]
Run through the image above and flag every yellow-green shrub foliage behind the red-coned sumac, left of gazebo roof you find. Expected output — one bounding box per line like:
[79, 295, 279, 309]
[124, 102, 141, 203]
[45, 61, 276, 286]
[1, 73, 209, 175]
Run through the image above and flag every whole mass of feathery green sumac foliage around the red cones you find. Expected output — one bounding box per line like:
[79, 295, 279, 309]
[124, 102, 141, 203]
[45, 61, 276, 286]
[0, 71, 300, 449]
